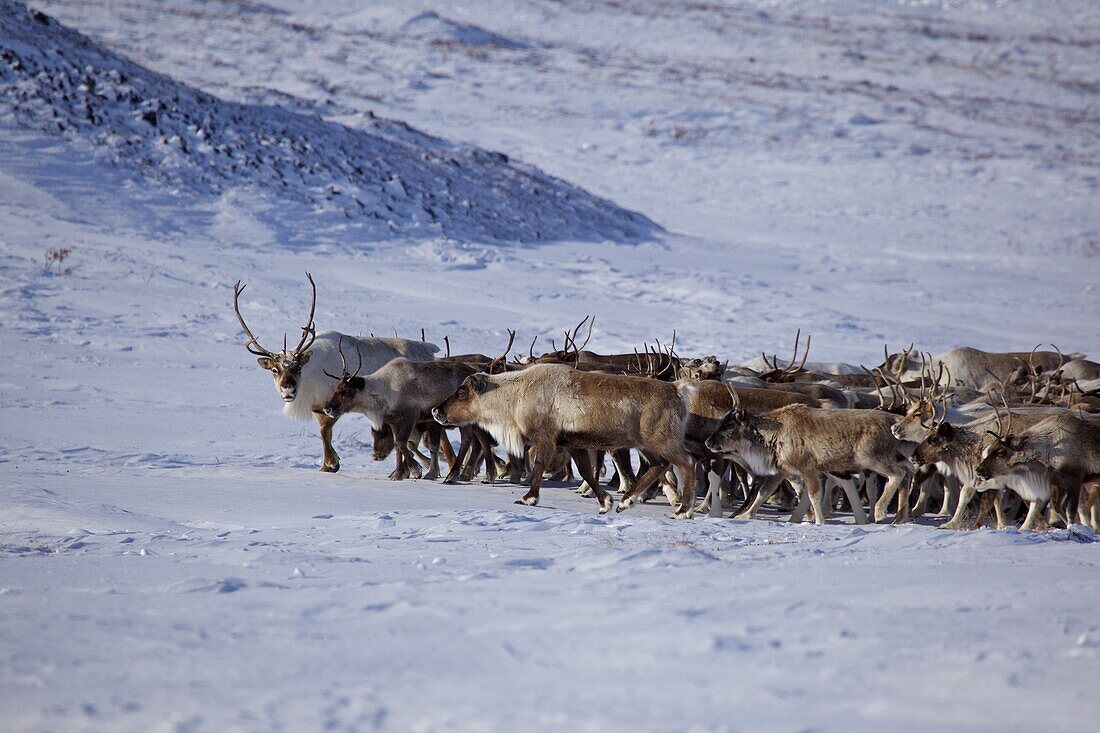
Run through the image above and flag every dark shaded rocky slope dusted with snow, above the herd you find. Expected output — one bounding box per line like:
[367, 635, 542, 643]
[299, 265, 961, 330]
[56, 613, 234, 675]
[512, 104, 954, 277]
[0, 0, 658, 242]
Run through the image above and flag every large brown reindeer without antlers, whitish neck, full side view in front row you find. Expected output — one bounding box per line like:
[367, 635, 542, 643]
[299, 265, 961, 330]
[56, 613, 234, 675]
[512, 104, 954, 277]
[432, 364, 693, 518]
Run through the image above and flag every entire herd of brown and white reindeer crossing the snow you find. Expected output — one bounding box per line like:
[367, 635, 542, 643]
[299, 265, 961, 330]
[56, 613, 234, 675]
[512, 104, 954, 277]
[233, 274, 1100, 530]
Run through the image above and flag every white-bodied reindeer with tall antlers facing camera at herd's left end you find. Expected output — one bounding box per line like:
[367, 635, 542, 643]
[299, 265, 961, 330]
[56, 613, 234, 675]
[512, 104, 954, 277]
[233, 273, 439, 473]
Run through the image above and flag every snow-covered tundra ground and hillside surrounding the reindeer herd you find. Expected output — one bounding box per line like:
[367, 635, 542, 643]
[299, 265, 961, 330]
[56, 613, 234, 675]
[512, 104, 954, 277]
[0, 0, 1100, 731]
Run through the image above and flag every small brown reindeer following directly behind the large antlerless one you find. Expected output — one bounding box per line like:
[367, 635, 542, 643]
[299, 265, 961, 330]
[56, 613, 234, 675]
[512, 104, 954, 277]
[706, 405, 912, 524]
